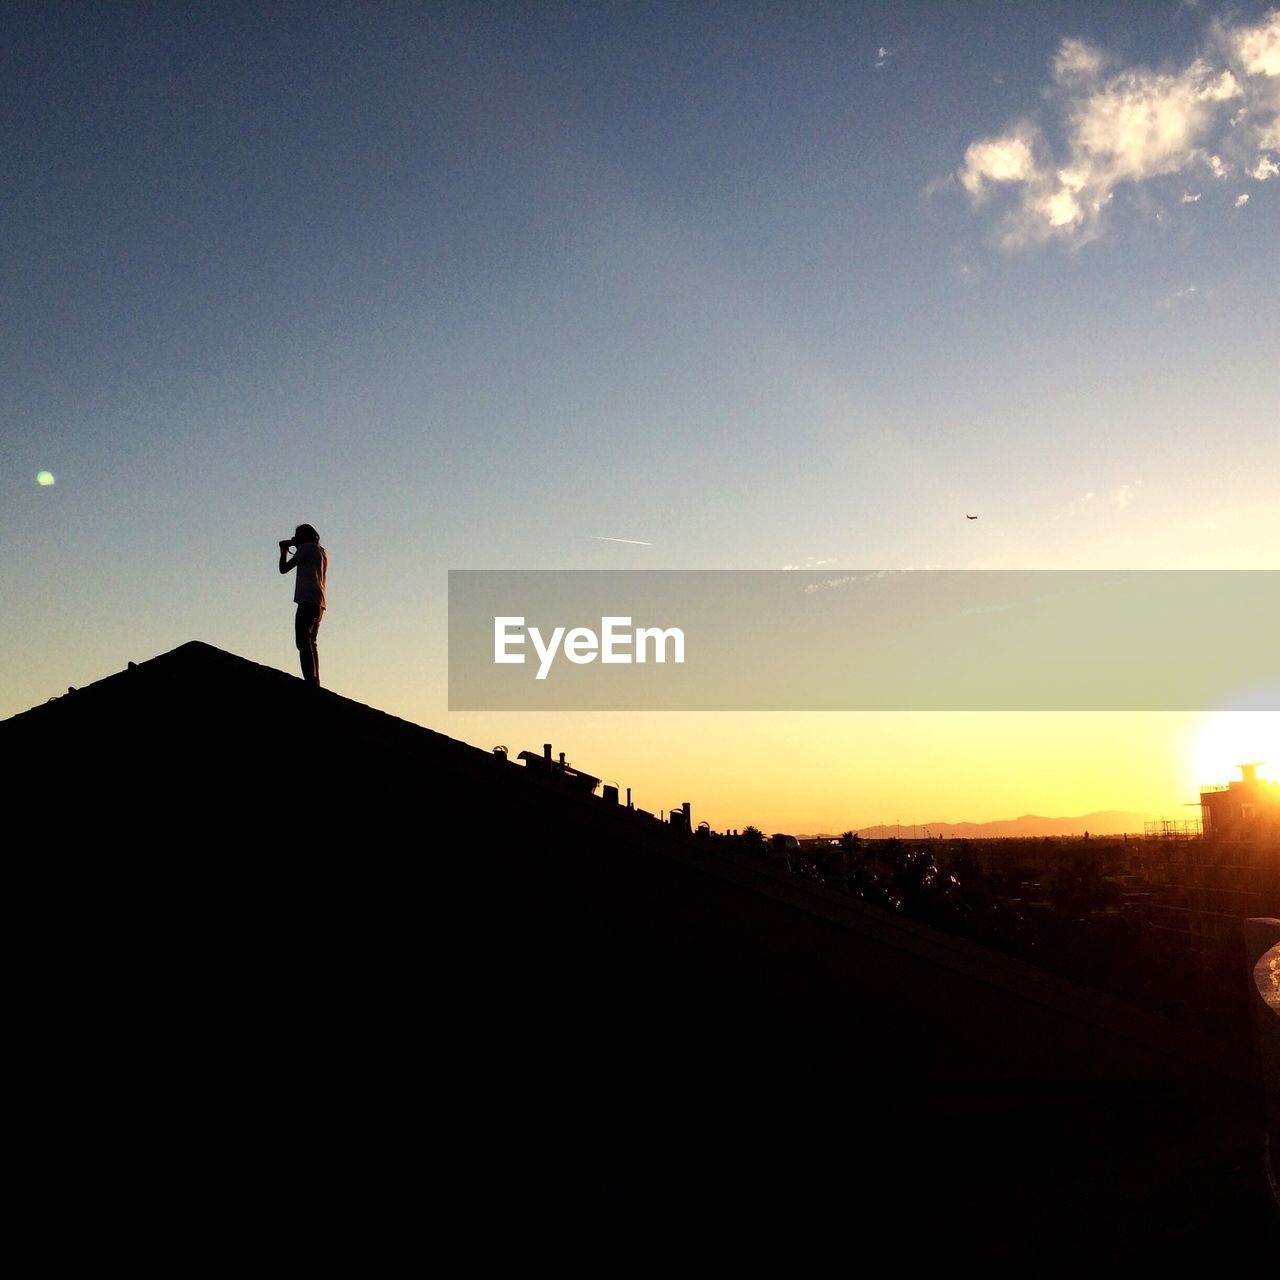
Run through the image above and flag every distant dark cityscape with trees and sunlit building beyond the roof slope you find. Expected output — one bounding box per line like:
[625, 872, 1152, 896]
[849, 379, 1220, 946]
[512, 744, 1280, 977]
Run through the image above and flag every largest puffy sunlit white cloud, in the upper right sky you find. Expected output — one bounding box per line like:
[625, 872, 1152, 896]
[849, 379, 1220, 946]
[955, 9, 1280, 250]
